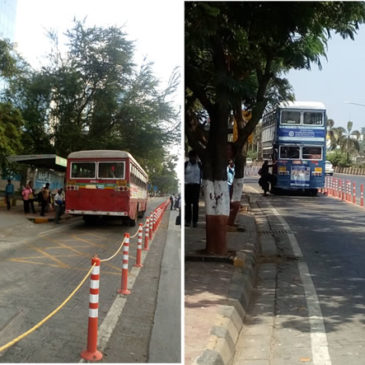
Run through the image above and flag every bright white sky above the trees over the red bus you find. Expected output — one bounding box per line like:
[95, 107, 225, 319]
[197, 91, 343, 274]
[15, 0, 184, 180]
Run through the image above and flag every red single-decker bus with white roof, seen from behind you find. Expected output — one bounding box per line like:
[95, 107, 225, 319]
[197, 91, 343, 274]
[66, 150, 148, 225]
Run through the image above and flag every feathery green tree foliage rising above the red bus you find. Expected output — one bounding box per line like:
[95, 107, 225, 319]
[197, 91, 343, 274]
[2, 21, 180, 191]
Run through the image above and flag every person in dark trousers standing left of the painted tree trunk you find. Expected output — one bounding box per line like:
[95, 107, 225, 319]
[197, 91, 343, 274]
[185, 150, 202, 227]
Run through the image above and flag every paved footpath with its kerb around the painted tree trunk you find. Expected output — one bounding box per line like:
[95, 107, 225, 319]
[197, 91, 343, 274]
[185, 194, 258, 365]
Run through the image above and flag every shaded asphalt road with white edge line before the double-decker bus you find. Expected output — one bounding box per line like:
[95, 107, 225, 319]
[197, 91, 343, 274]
[242, 180, 365, 365]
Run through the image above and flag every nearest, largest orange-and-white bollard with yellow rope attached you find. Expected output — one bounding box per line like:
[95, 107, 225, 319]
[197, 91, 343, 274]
[81, 256, 103, 361]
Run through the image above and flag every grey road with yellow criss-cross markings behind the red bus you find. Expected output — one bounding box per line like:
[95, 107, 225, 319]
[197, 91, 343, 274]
[0, 198, 180, 363]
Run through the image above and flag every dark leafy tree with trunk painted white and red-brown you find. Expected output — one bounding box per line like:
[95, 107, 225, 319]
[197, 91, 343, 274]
[185, 2, 365, 254]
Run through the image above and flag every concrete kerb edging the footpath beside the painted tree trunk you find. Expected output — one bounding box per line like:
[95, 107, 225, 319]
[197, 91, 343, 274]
[194, 193, 259, 365]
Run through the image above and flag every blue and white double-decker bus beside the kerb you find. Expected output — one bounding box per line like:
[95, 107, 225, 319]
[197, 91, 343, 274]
[261, 101, 326, 195]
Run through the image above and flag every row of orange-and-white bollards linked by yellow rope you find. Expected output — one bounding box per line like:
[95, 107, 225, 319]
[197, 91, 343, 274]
[0, 200, 170, 361]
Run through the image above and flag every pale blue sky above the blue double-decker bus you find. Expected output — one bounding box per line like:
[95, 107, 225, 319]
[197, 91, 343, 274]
[286, 25, 365, 132]
